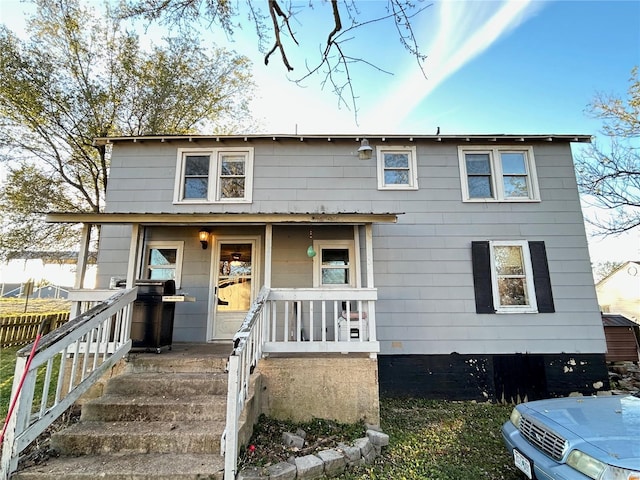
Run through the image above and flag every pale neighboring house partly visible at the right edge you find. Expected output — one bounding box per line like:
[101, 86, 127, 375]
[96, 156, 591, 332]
[596, 262, 640, 324]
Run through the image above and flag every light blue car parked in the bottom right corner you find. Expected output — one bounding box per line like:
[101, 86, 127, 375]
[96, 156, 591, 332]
[502, 394, 640, 480]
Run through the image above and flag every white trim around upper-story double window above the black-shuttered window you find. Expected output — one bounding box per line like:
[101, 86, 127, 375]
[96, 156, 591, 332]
[458, 145, 540, 203]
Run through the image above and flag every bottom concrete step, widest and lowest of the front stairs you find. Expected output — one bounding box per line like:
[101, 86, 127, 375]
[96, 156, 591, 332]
[12, 454, 224, 480]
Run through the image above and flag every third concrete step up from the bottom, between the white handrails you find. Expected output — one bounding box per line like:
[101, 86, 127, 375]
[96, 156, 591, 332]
[80, 395, 227, 422]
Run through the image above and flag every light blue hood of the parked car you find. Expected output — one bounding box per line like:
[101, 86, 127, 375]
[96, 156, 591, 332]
[523, 395, 640, 469]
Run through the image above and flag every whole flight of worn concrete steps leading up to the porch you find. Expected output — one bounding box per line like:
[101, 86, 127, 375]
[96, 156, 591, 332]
[12, 344, 235, 480]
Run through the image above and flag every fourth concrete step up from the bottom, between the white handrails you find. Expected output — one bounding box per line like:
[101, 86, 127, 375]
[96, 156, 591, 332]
[105, 372, 227, 398]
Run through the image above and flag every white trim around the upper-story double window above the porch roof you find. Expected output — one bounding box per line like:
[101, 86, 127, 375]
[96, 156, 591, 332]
[173, 147, 254, 204]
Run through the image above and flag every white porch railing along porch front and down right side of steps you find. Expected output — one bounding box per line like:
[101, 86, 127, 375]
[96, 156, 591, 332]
[220, 288, 380, 480]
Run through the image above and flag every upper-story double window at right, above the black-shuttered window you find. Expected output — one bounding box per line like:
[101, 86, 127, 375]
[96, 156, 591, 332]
[458, 146, 540, 202]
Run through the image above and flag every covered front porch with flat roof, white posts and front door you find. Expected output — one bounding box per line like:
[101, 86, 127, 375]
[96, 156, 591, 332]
[47, 213, 397, 358]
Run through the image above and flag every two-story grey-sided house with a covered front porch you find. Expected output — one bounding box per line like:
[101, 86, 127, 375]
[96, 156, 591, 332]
[48, 135, 608, 411]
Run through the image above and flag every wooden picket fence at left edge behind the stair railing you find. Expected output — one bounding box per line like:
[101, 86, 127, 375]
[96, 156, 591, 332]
[0, 312, 69, 348]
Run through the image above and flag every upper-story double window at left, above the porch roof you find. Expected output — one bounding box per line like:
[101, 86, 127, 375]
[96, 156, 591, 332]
[174, 148, 253, 203]
